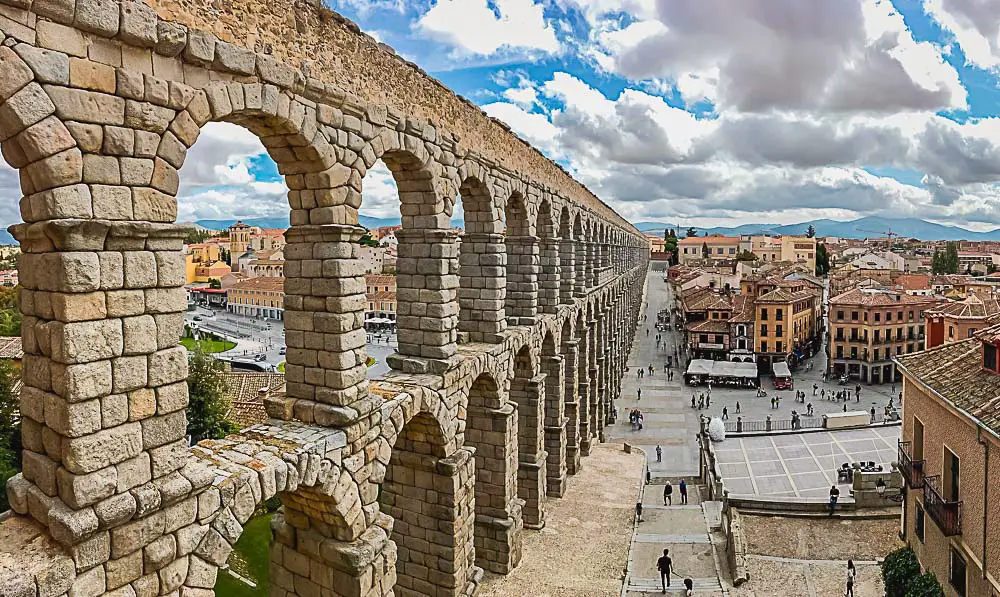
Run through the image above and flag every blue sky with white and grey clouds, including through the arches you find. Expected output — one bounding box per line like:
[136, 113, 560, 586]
[0, 0, 1000, 230]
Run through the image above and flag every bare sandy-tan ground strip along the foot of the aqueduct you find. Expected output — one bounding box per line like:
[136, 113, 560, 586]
[477, 443, 643, 597]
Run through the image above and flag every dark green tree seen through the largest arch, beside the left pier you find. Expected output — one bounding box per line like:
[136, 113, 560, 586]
[187, 346, 238, 442]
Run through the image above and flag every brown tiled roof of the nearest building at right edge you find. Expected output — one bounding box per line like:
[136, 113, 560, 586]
[896, 336, 1000, 433]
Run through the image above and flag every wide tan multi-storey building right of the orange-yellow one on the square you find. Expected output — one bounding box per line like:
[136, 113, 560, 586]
[828, 288, 941, 383]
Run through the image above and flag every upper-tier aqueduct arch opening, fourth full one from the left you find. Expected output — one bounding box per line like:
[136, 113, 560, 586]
[504, 191, 539, 326]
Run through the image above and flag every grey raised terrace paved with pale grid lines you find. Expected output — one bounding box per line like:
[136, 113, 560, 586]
[715, 425, 900, 497]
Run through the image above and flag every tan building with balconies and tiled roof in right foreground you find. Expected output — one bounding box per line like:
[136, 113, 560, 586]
[895, 325, 1000, 597]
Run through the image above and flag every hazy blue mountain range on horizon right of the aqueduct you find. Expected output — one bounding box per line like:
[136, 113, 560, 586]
[635, 216, 1000, 241]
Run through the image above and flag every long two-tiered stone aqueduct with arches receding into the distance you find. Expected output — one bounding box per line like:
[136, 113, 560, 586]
[0, 0, 648, 597]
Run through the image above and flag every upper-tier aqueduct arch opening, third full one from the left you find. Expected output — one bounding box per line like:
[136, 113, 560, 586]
[458, 170, 507, 343]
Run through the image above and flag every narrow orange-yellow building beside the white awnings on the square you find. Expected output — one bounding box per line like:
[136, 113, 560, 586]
[754, 288, 817, 371]
